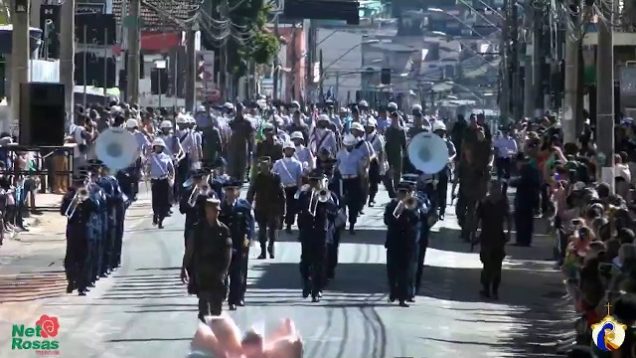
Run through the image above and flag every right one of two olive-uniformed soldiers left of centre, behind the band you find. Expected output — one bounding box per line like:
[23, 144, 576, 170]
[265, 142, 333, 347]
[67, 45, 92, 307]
[227, 104, 256, 180]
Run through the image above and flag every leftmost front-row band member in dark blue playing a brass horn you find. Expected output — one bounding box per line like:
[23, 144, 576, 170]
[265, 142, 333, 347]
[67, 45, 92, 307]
[60, 174, 95, 296]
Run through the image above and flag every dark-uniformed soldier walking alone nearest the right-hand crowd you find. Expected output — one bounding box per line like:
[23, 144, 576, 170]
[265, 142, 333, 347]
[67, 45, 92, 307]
[476, 180, 512, 299]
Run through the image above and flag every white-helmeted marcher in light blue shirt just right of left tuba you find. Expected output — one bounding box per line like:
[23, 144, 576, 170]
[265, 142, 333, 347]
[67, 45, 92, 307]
[148, 138, 175, 229]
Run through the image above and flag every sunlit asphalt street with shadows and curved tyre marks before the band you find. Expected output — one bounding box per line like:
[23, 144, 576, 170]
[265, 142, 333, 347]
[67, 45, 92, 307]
[0, 187, 572, 358]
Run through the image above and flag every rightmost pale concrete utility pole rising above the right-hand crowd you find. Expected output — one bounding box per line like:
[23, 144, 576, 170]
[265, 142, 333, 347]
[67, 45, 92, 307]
[596, 0, 614, 192]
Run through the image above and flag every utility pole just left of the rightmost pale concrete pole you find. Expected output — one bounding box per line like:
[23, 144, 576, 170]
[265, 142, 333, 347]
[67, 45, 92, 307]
[561, 4, 580, 143]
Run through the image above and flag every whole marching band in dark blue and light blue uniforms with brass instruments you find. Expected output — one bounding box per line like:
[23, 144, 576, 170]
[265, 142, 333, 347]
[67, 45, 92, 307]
[61, 99, 468, 317]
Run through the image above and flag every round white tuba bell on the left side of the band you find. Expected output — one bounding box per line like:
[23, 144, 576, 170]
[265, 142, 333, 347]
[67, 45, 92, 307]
[95, 127, 140, 172]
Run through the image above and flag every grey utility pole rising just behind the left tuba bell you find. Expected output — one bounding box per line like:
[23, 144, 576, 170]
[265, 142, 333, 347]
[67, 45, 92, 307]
[126, 0, 141, 103]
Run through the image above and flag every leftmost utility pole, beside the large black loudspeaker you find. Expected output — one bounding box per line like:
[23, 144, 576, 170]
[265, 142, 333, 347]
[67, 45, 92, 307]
[9, 0, 30, 130]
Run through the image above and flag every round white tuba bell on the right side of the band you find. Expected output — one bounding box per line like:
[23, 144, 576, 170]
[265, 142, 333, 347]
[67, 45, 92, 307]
[407, 132, 449, 174]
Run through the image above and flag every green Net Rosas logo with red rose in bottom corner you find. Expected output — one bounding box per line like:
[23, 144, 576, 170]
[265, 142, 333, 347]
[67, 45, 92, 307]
[11, 314, 60, 354]
